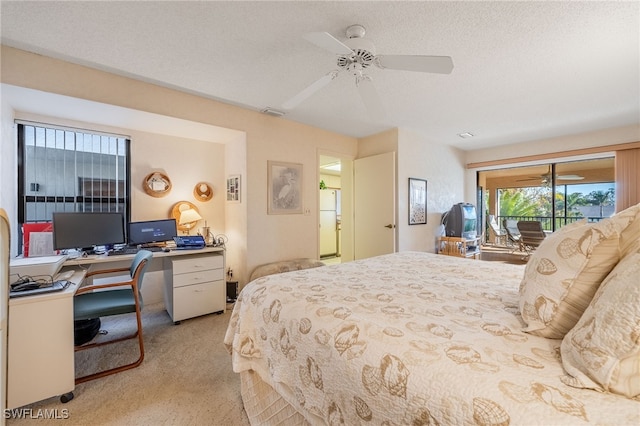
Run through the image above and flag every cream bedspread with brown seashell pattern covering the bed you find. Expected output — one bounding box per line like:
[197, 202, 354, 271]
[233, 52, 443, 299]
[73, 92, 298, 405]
[224, 252, 640, 425]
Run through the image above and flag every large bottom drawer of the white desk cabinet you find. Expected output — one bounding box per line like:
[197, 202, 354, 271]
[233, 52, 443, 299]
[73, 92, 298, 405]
[172, 281, 226, 321]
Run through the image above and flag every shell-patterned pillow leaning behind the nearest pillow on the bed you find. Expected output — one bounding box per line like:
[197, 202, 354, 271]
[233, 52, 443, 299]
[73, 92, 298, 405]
[520, 204, 640, 339]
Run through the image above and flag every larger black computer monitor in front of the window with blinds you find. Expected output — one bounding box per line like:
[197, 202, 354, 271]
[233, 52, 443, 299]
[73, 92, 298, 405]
[53, 212, 125, 252]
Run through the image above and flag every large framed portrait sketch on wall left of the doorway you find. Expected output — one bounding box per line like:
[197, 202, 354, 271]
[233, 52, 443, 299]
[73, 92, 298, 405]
[267, 161, 302, 214]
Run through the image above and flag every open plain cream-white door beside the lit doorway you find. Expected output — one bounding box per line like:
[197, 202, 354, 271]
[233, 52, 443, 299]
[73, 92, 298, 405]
[354, 152, 396, 259]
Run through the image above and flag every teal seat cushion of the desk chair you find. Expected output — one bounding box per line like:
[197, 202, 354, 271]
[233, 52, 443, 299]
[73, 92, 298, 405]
[73, 289, 136, 320]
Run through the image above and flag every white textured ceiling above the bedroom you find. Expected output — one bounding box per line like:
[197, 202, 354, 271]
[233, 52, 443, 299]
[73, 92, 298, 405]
[0, 0, 640, 149]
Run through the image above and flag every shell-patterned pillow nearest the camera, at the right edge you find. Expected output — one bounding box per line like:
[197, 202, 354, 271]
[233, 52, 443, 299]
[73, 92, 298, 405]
[560, 250, 640, 398]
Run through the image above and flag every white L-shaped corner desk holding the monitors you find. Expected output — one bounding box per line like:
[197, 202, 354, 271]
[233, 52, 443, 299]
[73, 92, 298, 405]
[7, 247, 226, 409]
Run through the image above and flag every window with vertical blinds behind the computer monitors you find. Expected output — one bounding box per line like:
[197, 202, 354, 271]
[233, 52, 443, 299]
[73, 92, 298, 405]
[17, 122, 130, 253]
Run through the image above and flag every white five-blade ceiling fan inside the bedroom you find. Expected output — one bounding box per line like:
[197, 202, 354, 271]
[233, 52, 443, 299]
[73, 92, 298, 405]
[282, 25, 453, 120]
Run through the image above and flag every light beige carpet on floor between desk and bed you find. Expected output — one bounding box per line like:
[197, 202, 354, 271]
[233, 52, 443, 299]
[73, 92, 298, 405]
[6, 303, 249, 426]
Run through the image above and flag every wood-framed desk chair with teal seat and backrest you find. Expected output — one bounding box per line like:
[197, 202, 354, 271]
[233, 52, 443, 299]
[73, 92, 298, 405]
[73, 250, 152, 384]
